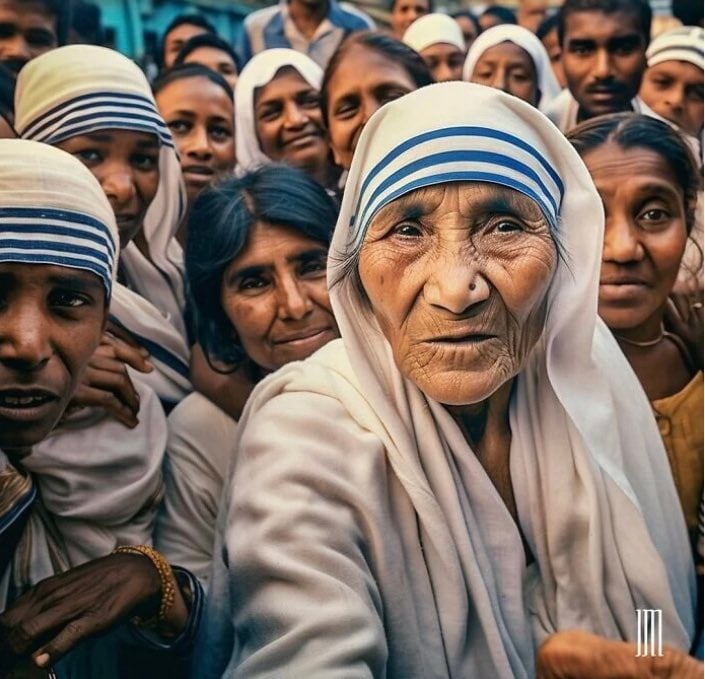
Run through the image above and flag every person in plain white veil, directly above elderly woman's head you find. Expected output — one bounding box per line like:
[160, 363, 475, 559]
[463, 24, 561, 111]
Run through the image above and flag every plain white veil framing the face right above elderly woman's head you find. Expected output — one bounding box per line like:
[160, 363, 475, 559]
[463, 24, 561, 110]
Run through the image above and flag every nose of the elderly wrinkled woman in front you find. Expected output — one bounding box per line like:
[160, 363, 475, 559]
[423, 253, 490, 315]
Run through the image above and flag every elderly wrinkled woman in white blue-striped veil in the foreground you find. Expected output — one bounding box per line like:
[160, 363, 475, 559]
[198, 83, 695, 679]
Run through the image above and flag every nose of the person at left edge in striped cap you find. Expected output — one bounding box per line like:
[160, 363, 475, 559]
[0, 300, 52, 372]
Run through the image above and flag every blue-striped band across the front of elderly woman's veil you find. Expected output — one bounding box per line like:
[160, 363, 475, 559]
[350, 125, 565, 247]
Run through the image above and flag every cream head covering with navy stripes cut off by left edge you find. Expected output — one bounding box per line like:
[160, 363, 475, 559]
[0, 139, 119, 300]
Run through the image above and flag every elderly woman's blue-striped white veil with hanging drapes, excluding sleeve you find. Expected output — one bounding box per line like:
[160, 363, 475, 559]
[330, 83, 695, 677]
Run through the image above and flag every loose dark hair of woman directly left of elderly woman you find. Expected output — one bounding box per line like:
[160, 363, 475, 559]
[185, 164, 338, 372]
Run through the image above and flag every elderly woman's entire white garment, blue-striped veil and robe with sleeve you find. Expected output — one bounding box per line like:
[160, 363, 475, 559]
[197, 83, 695, 679]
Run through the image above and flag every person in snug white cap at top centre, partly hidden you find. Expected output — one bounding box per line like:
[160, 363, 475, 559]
[402, 13, 465, 82]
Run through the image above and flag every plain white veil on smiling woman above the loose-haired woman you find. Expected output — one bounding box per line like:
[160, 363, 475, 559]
[235, 47, 323, 172]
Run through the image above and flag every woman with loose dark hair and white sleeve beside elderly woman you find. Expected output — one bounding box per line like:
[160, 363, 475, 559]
[156, 165, 338, 579]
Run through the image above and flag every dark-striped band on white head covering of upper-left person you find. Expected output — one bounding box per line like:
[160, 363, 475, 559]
[18, 91, 174, 148]
